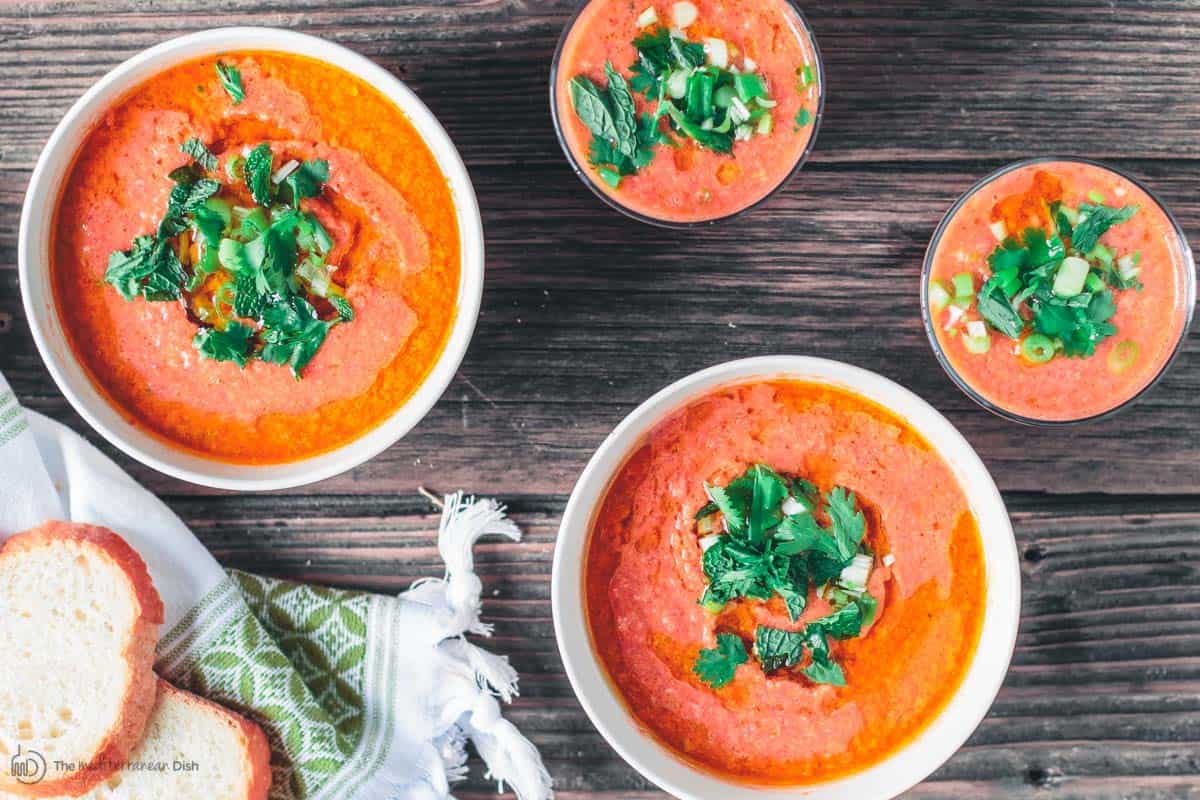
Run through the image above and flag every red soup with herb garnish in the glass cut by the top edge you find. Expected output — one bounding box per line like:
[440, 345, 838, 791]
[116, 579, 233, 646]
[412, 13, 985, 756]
[553, 0, 821, 223]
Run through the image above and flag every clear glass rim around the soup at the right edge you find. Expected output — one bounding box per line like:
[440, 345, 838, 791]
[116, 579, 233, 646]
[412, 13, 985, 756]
[920, 155, 1196, 428]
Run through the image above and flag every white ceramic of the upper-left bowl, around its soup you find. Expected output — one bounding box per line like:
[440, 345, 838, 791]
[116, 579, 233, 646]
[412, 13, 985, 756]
[17, 28, 484, 491]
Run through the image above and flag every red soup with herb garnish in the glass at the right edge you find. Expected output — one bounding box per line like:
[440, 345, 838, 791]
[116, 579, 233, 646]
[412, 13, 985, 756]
[926, 161, 1195, 422]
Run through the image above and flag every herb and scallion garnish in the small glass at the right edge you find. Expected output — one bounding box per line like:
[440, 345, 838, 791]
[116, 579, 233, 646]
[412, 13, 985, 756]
[930, 174, 1141, 363]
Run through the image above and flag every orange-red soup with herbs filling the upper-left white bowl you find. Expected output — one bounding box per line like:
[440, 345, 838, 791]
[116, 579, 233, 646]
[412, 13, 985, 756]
[50, 52, 460, 463]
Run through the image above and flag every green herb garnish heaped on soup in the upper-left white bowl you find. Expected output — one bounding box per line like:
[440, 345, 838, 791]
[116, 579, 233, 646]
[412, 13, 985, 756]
[104, 138, 354, 379]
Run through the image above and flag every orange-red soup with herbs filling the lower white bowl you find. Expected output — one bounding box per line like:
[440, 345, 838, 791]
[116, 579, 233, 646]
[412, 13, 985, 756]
[584, 380, 986, 784]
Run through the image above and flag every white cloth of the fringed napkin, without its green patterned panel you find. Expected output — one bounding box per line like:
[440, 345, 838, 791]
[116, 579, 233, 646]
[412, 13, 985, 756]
[0, 375, 552, 800]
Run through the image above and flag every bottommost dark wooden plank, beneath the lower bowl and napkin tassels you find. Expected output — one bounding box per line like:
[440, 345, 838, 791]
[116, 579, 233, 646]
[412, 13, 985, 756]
[150, 493, 1200, 800]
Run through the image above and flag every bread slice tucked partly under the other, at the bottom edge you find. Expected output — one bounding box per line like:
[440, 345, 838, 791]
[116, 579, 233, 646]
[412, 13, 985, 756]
[0, 680, 271, 800]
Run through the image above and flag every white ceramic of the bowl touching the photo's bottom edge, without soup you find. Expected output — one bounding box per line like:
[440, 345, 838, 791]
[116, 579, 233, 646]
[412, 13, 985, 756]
[551, 356, 1021, 800]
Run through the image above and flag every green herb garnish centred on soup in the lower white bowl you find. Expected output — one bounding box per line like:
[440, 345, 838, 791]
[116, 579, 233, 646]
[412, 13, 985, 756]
[697, 464, 876, 685]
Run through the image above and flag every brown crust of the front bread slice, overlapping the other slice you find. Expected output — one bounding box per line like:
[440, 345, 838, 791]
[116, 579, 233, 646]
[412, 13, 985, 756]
[0, 521, 163, 798]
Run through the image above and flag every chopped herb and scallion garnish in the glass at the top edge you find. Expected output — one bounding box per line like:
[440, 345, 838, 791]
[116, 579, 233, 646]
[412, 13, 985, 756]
[569, 19, 806, 188]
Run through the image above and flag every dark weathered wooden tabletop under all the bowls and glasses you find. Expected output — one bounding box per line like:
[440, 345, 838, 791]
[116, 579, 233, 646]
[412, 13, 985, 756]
[0, 0, 1200, 800]
